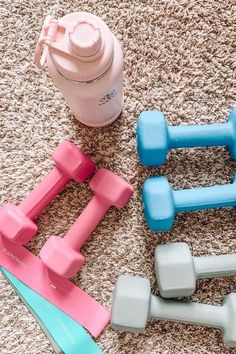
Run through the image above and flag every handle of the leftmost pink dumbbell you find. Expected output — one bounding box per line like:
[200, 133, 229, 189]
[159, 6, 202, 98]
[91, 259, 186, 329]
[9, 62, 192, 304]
[19, 167, 70, 220]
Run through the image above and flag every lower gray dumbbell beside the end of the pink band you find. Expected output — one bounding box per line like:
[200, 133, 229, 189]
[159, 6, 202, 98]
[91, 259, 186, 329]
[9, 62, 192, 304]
[111, 275, 236, 347]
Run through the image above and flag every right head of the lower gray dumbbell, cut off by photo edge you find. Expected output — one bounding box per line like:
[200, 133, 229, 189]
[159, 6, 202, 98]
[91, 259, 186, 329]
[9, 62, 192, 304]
[223, 293, 236, 347]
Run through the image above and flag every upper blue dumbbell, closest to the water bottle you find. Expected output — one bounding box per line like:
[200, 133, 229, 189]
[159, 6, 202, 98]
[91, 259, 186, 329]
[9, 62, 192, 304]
[137, 108, 236, 166]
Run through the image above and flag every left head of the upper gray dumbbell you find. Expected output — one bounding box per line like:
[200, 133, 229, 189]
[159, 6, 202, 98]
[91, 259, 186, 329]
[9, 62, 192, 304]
[155, 242, 196, 298]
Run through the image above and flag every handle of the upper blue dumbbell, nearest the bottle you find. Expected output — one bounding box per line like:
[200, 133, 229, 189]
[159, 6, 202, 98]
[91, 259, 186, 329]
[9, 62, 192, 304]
[168, 122, 234, 148]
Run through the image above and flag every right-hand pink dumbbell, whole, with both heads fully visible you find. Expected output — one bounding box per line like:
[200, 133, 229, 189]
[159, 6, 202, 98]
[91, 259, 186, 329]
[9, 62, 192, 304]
[40, 168, 133, 278]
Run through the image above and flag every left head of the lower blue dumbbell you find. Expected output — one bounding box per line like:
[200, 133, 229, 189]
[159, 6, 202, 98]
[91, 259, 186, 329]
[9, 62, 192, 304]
[142, 176, 175, 231]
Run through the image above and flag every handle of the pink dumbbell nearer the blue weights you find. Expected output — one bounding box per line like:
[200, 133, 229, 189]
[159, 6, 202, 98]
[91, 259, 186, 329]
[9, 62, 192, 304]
[64, 196, 111, 251]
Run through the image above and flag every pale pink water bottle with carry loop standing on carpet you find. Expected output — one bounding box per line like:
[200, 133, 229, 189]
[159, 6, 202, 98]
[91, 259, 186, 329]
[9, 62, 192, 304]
[34, 12, 123, 127]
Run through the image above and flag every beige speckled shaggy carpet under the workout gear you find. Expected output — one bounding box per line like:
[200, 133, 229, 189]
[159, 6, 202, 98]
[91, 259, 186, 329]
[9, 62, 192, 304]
[0, 0, 236, 354]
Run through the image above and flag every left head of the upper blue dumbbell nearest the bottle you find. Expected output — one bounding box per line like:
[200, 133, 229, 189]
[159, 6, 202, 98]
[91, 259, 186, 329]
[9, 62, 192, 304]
[137, 111, 168, 166]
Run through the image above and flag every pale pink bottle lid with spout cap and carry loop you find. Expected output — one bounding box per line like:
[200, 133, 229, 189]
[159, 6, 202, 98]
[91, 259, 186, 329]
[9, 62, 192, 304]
[34, 12, 114, 82]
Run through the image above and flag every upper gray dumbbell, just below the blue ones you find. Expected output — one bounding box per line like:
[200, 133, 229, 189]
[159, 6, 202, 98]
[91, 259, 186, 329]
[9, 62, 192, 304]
[155, 242, 236, 298]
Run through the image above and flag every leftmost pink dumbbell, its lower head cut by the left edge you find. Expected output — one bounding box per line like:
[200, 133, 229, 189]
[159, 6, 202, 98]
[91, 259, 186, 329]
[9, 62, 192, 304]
[0, 141, 95, 244]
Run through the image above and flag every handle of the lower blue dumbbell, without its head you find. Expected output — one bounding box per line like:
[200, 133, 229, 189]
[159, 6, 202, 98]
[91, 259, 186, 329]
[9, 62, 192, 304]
[173, 183, 236, 212]
